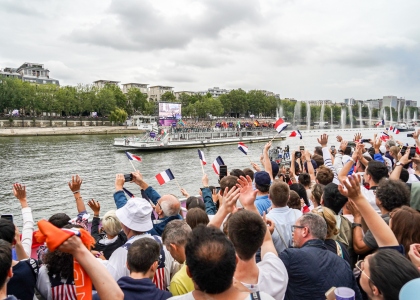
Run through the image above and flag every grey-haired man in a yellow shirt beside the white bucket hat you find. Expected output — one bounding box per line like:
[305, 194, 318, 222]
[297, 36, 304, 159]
[162, 220, 194, 296]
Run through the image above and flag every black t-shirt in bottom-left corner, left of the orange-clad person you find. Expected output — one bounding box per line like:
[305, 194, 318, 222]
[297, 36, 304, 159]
[6, 258, 38, 300]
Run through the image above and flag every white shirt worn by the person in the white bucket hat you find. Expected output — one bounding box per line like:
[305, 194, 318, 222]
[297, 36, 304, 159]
[104, 233, 180, 287]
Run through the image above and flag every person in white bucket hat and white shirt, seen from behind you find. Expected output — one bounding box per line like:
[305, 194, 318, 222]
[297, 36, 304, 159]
[104, 198, 179, 290]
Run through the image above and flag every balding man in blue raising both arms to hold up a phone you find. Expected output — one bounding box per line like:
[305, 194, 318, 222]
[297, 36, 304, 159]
[114, 171, 182, 236]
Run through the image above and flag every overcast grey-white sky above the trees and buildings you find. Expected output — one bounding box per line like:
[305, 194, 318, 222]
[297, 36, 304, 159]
[0, 0, 420, 101]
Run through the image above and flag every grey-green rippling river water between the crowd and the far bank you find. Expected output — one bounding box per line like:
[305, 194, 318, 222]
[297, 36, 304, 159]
[0, 129, 414, 227]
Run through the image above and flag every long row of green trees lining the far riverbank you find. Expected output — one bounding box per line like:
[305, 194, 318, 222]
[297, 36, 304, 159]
[0, 78, 417, 122]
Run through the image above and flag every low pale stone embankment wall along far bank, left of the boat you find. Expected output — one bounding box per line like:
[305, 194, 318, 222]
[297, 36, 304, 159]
[0, 126, 144, 137]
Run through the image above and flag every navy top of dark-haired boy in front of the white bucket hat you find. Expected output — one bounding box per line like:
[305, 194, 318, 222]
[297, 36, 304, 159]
[93, 276, 172, 300]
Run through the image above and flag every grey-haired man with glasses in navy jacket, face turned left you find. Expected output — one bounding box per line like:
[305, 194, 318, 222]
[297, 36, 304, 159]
[280, 213, 362, 299]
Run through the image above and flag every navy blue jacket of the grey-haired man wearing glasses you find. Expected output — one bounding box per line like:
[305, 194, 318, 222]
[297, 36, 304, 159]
[280, 239, 362, 300]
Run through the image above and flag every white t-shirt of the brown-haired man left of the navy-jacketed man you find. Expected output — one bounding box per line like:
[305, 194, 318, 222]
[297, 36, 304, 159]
[242, 252, 289, 300]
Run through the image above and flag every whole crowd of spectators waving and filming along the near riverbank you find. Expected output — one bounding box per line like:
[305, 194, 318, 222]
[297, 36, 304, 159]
[0, 131, 420, 300]
